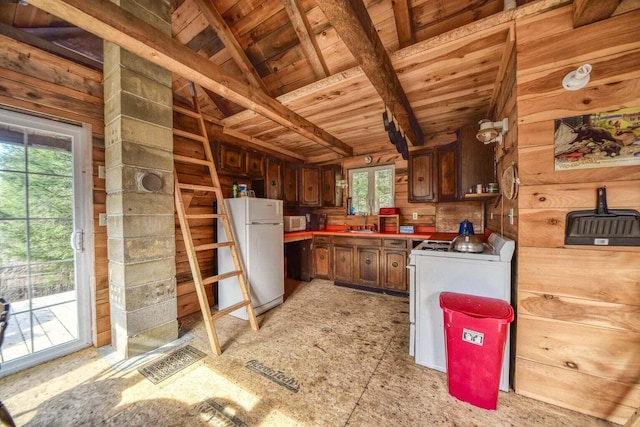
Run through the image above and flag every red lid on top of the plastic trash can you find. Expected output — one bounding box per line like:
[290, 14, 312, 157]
[440, 292, 513, 322]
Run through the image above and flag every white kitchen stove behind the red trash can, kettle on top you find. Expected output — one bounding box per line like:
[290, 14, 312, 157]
[407, 233, 515, 391]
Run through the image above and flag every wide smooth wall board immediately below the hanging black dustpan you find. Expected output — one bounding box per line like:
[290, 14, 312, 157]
[517, 246, 640, 310]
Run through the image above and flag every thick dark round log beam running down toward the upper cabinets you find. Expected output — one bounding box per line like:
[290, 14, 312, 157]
[317, 0, 424, 145]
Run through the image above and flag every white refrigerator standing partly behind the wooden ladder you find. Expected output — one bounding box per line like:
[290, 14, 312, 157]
[217, 197, 284, 320]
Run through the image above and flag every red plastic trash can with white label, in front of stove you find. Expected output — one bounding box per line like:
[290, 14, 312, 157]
[440, 292, 513, 409]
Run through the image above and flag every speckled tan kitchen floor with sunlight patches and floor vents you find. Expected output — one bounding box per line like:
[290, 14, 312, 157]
[0, 280, 615, 427]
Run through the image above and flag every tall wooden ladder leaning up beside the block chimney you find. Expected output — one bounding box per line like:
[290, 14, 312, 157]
[173, 85, 258, 355]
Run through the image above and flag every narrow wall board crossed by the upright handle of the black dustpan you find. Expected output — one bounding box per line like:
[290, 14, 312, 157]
[518, 181, 640, 210]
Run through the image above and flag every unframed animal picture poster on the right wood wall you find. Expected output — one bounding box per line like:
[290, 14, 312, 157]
[555, 107, 640, 170]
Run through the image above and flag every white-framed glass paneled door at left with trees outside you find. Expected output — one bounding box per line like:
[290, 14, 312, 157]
[0, 109, 93, 376]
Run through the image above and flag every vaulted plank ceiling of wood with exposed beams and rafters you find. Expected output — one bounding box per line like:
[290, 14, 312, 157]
[0, 0, 632, 163]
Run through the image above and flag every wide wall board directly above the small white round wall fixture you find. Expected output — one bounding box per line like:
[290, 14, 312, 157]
[518, 10, 640, 76]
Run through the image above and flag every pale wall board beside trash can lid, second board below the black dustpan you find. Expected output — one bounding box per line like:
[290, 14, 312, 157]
[517, 290, 640, 334]
